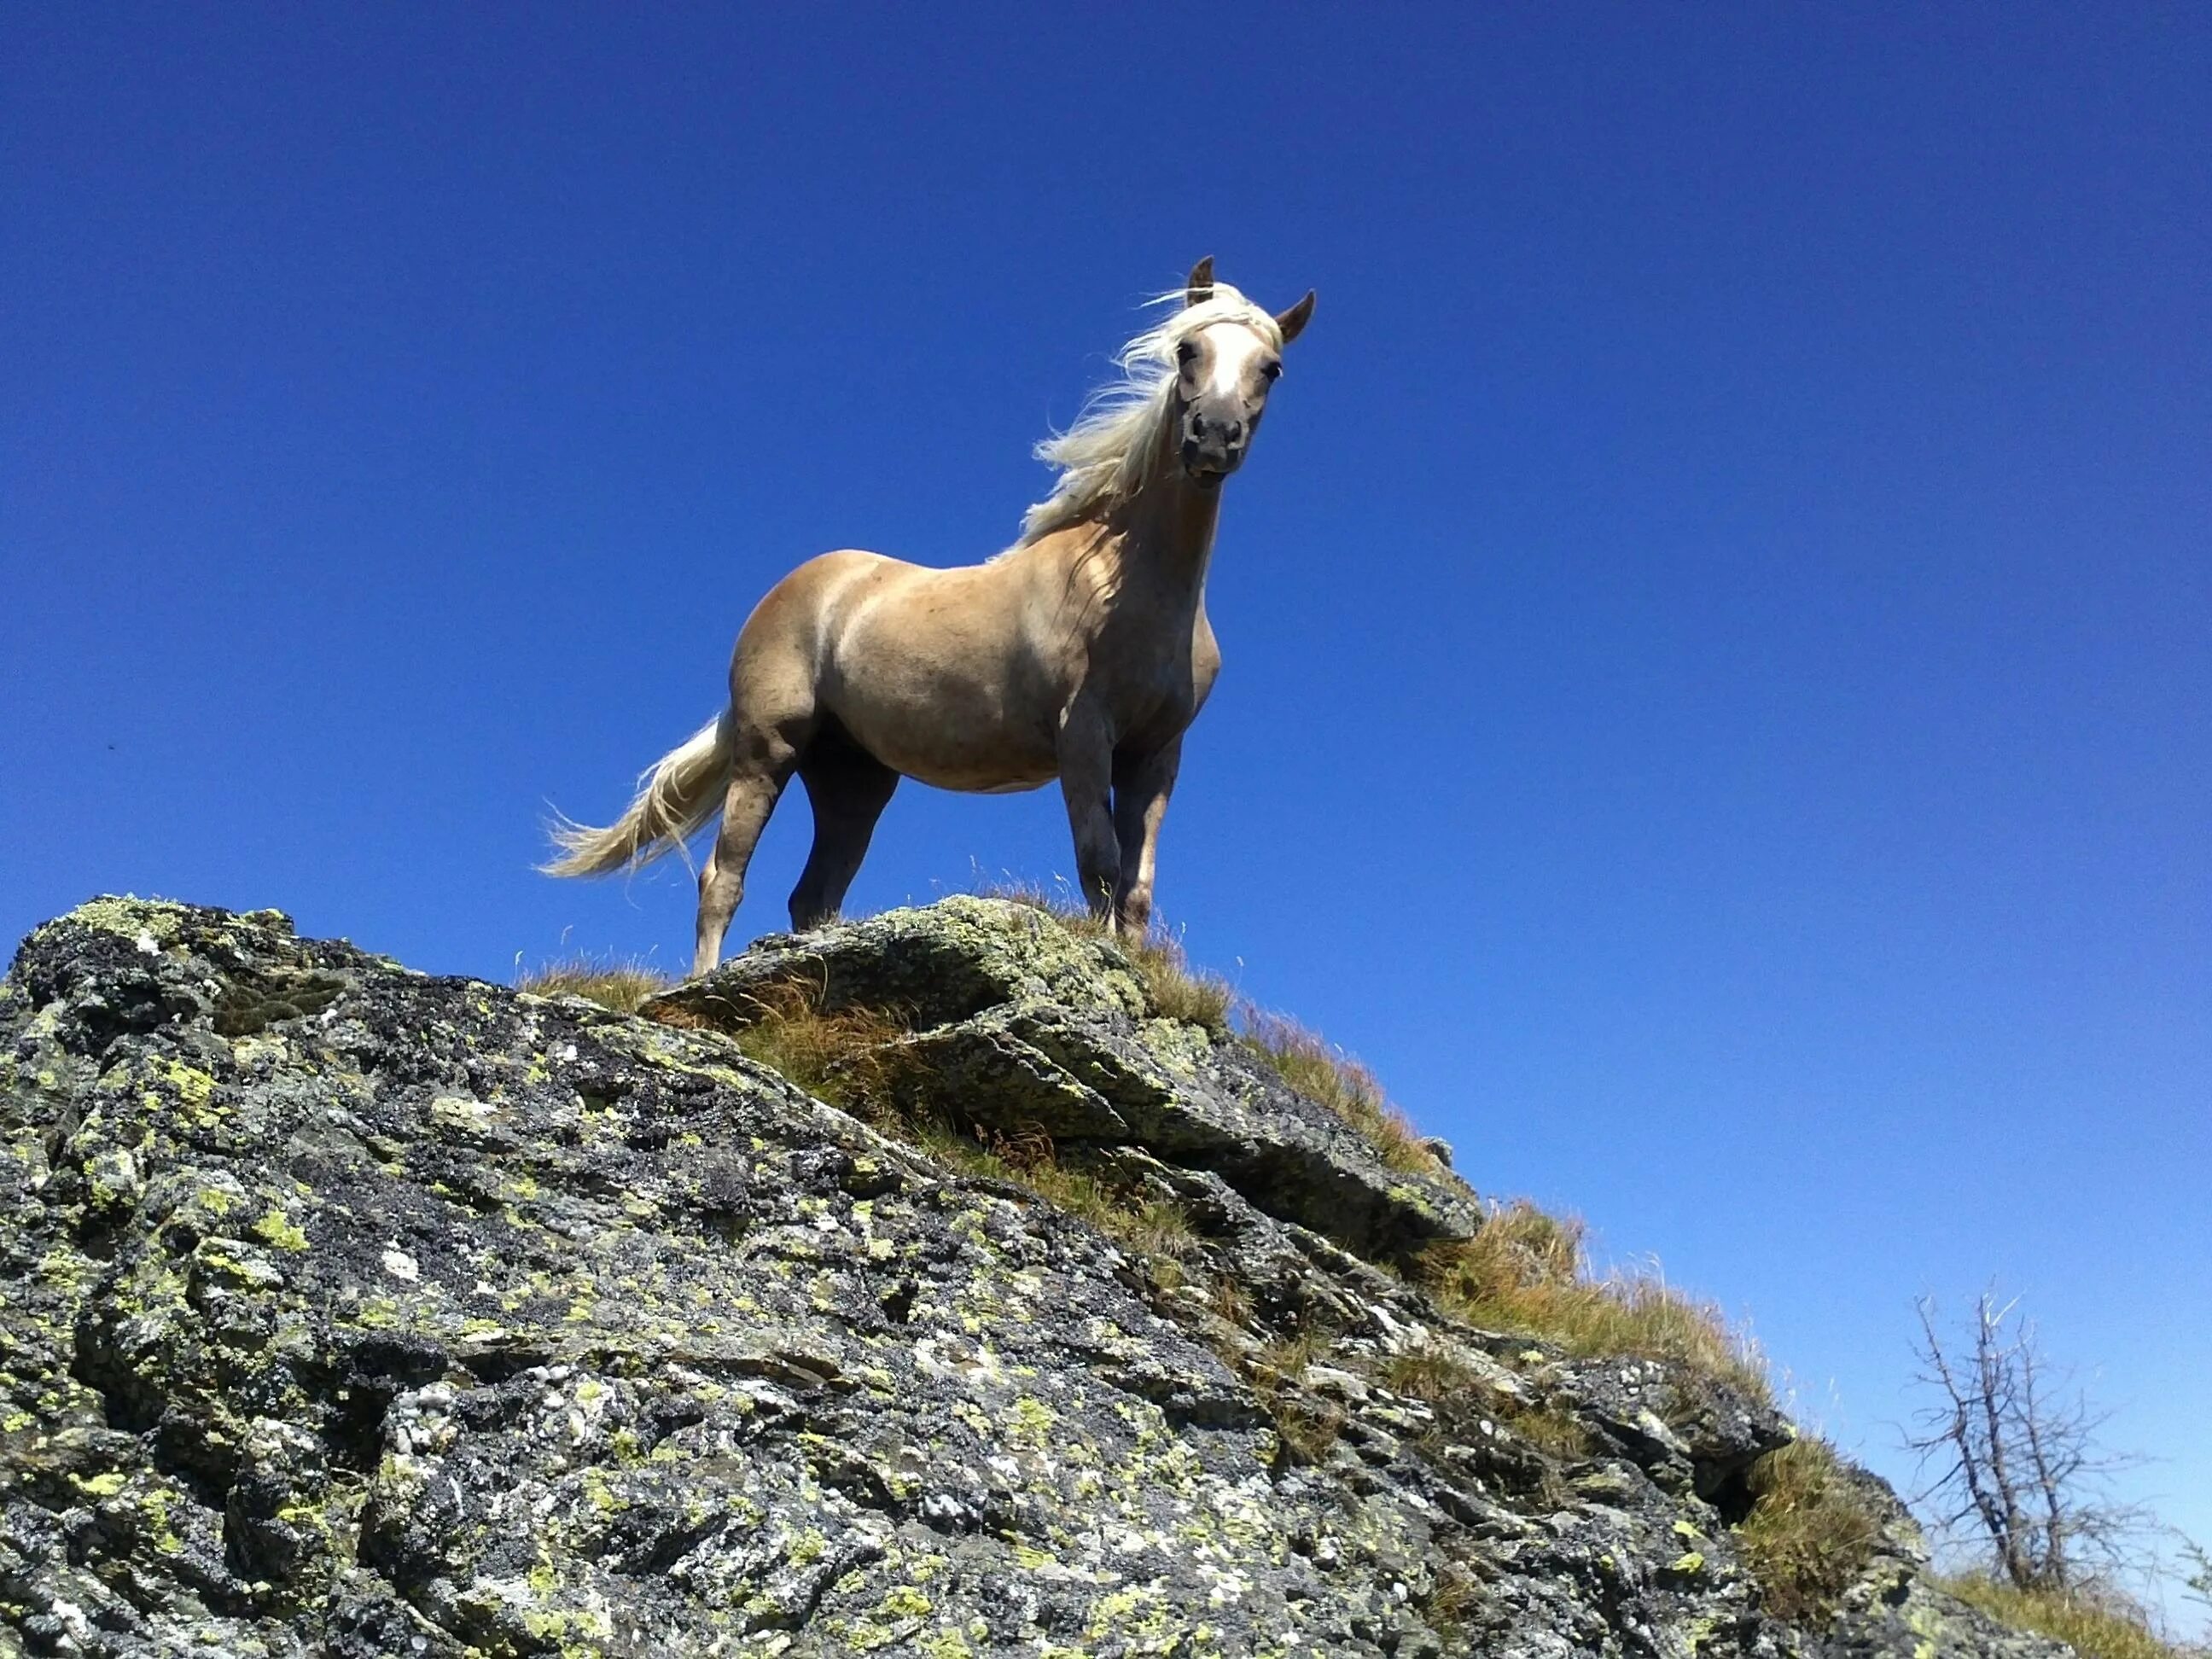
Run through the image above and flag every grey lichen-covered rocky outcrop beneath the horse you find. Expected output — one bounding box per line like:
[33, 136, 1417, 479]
[0, 900, 2059, 1659]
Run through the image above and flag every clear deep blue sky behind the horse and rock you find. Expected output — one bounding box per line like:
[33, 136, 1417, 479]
[0, 4, 2212, 1610]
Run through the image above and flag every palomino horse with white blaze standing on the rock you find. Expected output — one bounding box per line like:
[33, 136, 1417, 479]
[546, 259, 1314, 973]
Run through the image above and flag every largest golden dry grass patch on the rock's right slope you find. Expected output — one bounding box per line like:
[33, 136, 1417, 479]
[1413, 1201, 1770, 1400]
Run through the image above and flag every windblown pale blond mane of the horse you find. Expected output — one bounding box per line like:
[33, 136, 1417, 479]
[1016, 283, 1283, 546]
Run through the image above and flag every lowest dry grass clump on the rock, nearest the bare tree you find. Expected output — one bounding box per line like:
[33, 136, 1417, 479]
[1737, 1438, 1880, 1626]
